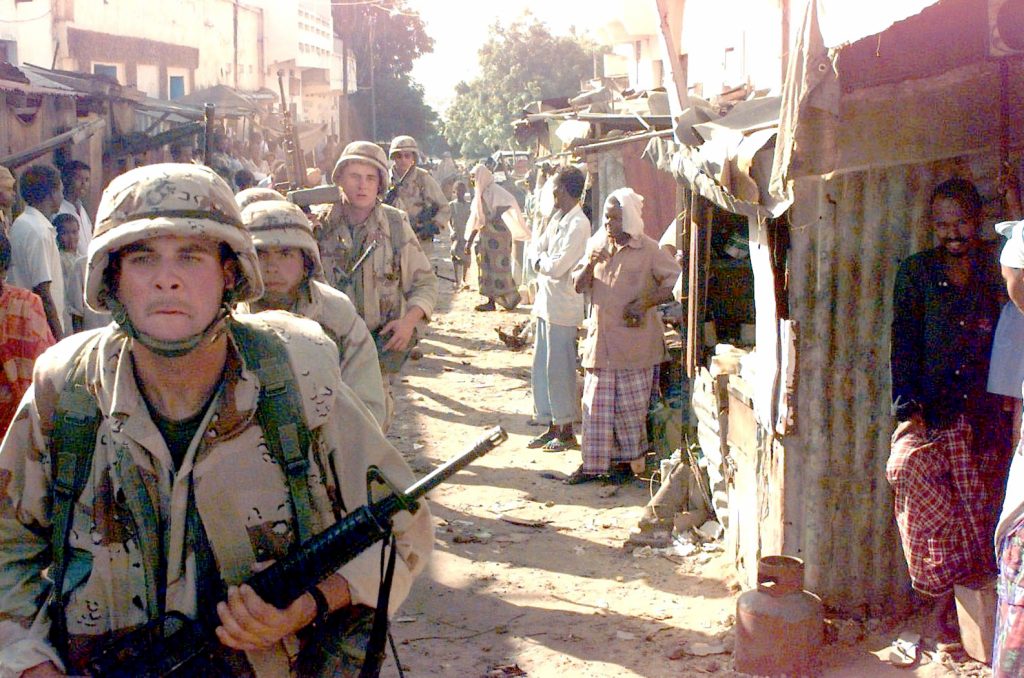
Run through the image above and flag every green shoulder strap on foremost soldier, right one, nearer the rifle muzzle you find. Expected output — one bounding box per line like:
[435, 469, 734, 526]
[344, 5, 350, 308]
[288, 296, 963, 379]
[229, 321, 315, 542]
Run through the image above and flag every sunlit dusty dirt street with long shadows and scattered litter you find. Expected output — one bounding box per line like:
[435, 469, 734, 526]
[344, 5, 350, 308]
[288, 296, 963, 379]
[372, 250, 990, 678]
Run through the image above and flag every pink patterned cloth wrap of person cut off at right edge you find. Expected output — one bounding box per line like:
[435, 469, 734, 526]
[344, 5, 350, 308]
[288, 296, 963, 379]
[992, 520, 1024, 678]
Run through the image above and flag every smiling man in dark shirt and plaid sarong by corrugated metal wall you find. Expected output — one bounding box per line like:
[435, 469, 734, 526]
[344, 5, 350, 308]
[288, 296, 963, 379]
[886, 178, 1011, 640]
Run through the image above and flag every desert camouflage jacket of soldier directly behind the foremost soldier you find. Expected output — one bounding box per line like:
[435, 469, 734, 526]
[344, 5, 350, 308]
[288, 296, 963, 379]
[238, 281, 386, 424]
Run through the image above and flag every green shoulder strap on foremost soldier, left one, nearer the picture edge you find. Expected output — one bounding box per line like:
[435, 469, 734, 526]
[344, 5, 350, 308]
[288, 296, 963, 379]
[50, 337, 99, 659]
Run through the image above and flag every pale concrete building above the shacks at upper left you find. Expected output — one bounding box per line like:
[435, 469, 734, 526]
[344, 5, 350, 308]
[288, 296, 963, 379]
[0, 0, 355, 126]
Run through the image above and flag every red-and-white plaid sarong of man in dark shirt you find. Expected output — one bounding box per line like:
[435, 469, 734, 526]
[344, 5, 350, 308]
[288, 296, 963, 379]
[886, 416, 992, 596]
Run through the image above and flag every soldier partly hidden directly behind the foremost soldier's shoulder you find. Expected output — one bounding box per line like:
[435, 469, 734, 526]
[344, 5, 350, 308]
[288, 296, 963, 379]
[238, 198, 386, 424]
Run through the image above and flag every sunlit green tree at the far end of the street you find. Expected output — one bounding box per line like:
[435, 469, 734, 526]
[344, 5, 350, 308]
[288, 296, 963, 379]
[444, 15, 596, 158]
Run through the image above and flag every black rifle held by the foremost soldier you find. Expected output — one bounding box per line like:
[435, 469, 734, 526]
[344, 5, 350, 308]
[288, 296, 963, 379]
[89, 426, 508, 678]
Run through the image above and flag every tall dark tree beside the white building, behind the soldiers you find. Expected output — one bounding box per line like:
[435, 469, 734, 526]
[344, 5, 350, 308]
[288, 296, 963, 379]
[332, 0, 443, 149]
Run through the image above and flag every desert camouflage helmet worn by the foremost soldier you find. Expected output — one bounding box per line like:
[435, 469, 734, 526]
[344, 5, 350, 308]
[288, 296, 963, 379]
[85, 163, 263, 312]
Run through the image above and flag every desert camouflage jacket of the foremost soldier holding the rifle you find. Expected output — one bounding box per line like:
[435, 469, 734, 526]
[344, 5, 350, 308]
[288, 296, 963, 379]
[0, 311, 433, 676]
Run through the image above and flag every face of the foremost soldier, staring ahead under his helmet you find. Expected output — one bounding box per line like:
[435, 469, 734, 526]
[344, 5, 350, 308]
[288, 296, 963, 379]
[117, 236, 234, 341]
